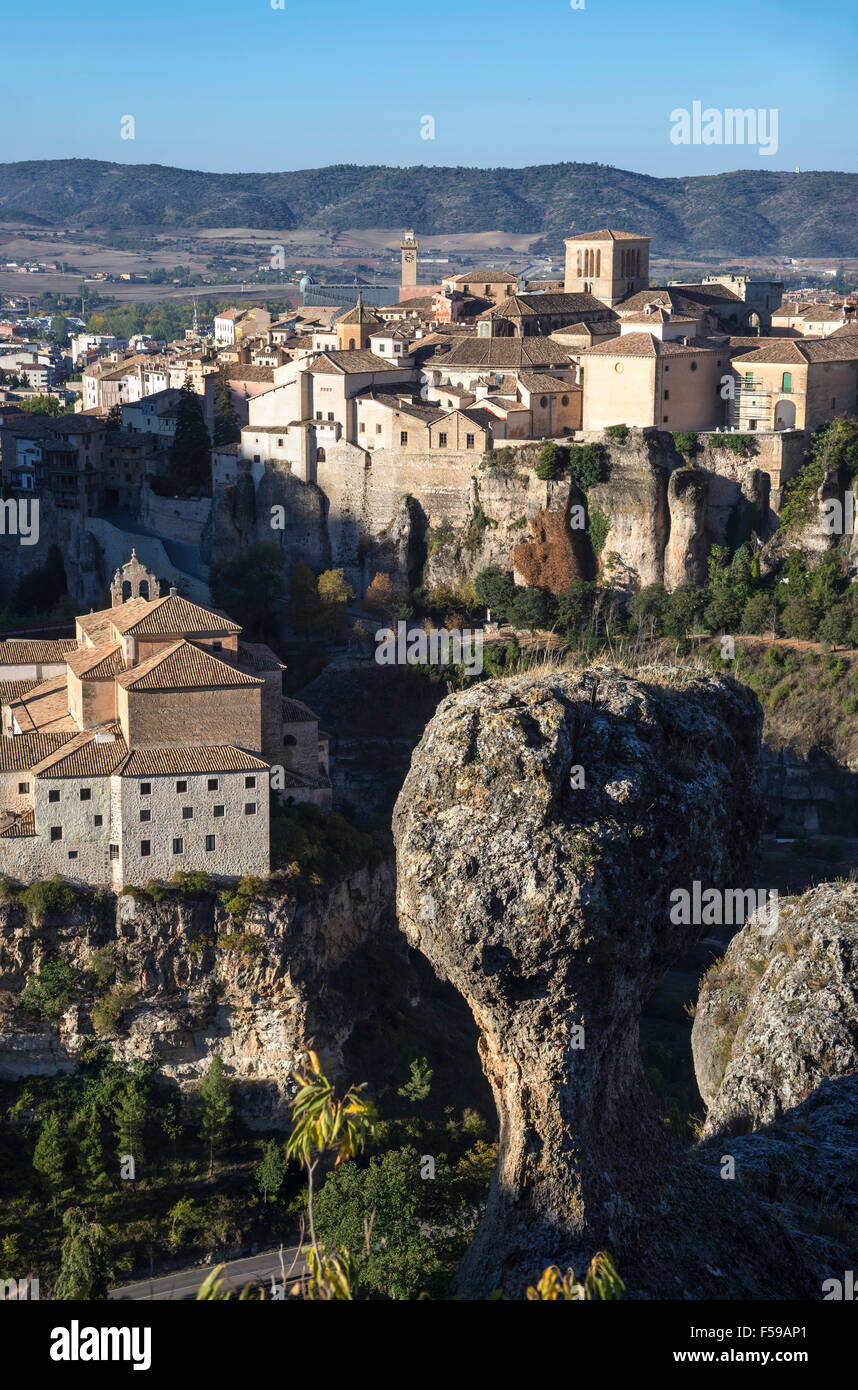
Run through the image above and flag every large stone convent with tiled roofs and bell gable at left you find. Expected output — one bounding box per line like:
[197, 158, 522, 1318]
[0, 555, 331, 890]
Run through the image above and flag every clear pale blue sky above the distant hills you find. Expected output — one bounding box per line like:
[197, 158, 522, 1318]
[6, 0, 858, 177]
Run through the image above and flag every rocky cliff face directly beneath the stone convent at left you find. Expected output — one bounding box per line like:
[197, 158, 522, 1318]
[0, 862, 408, 1125]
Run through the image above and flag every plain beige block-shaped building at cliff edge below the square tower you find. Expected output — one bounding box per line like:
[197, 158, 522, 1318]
[578, 332, 729, 430]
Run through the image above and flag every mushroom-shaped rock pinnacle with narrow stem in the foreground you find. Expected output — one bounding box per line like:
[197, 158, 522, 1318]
[394, 667, 819, 1298]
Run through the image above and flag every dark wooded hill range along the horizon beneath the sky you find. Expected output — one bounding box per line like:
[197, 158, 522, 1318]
[0, 160, 858, 257]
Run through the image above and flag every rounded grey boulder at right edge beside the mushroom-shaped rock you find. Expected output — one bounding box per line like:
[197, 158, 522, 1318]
[691, 883, 858, 1136]
